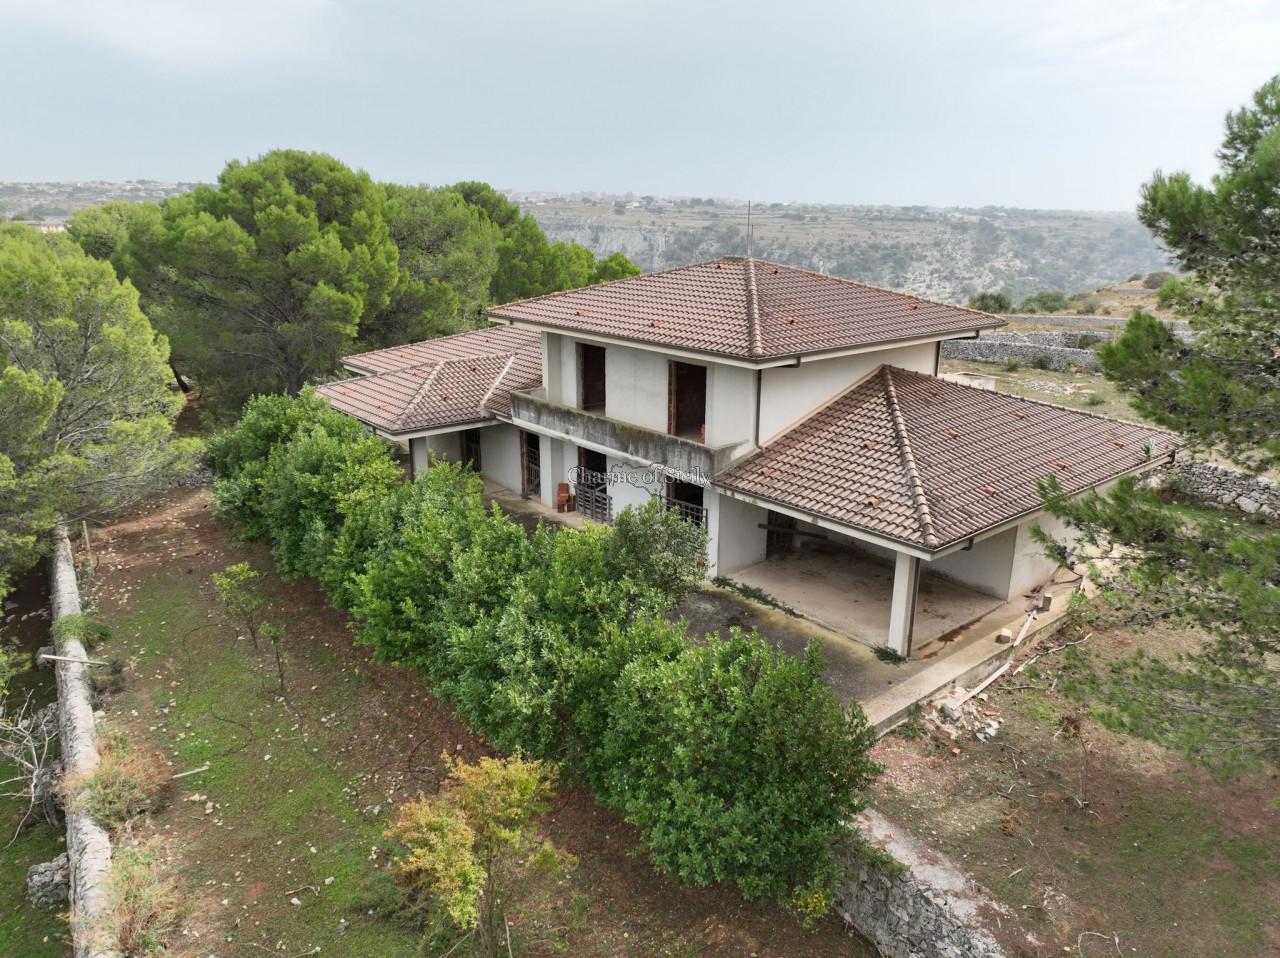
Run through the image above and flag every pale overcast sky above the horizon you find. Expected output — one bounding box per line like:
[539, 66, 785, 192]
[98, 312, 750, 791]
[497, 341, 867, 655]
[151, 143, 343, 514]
[0, 0, 1280, 209]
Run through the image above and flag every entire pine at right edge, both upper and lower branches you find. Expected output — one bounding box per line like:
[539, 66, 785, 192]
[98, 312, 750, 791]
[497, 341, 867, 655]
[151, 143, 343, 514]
[1044, 77, 1280, 768]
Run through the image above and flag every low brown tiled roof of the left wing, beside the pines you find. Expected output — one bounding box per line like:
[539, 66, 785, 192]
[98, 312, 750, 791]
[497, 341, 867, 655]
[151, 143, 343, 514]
[316, 327, 543, 434]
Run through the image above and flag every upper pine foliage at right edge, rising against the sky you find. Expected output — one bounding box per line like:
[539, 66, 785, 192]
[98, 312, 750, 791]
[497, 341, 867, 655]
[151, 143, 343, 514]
[1101, 77, 1280, 469]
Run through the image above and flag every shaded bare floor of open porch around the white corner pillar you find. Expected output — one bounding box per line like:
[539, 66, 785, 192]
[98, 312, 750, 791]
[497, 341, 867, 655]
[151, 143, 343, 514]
[730, 543, 1005, 654]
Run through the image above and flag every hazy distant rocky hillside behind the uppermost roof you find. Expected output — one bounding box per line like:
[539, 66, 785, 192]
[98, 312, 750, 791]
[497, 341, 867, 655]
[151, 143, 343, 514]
[515, 193, 1166, 302]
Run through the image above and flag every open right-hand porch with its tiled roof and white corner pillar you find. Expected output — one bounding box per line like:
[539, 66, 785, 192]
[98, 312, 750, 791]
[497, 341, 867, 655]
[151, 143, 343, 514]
[713, 366, 1179, 656]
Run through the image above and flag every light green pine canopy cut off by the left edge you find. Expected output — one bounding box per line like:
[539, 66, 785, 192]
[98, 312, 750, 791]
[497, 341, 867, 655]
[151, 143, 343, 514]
[0, 227, 198, 593]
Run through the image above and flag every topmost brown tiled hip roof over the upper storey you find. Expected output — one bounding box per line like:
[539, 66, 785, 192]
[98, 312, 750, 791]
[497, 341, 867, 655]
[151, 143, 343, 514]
[489, 256, 1005, 360]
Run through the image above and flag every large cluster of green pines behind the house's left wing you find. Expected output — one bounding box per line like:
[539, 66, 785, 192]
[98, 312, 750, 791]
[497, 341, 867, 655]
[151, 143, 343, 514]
[68, 156, 639, 407]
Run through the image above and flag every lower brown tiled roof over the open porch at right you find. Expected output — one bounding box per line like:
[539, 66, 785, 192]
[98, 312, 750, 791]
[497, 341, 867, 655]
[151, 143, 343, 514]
[714, 366, 1181, 551]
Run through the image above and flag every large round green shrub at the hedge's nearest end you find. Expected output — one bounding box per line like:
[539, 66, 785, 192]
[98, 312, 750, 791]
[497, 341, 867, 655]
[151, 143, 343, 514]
[600, 629, 878, 902]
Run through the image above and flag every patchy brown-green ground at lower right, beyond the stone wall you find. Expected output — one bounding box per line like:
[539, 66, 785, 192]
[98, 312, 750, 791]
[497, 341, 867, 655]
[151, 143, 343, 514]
[876, 617, 1280, 958]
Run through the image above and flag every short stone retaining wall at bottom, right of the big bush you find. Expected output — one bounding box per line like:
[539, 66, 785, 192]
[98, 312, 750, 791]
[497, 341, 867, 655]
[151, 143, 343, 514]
[836, 809, 1033, 958]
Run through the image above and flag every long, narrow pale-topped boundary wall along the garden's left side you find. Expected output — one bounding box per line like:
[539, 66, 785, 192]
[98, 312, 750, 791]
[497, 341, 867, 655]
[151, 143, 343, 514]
[49, 524, 118, 958]
